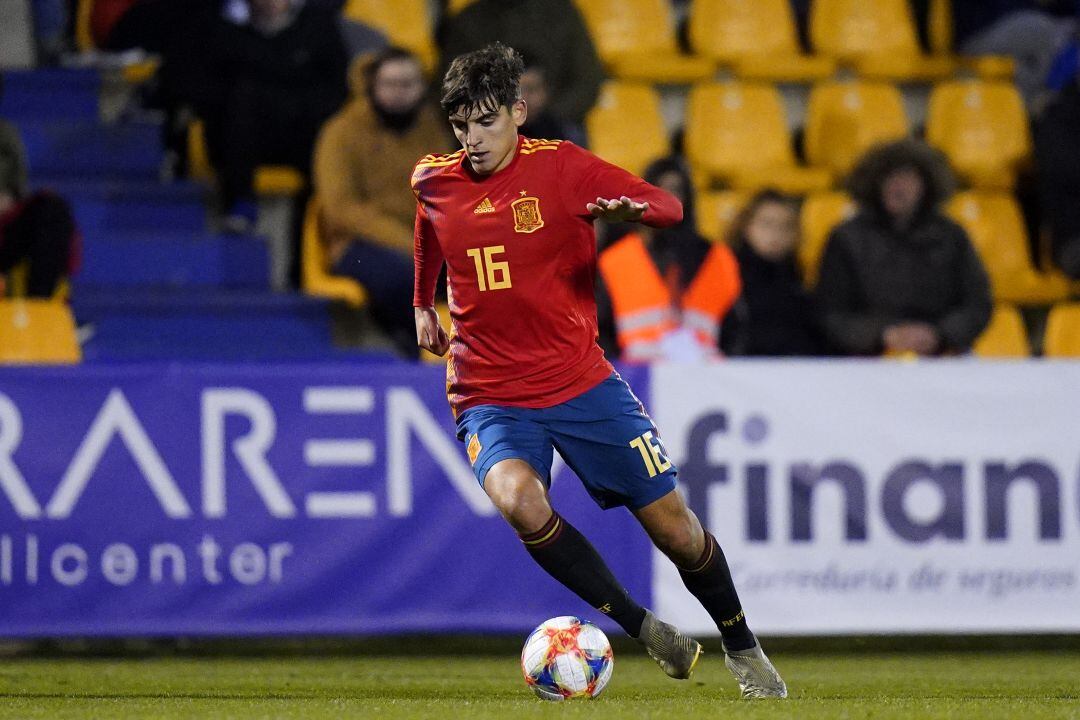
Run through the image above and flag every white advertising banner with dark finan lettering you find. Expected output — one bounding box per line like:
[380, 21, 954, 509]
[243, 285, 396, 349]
[651, 359, 1080, 634]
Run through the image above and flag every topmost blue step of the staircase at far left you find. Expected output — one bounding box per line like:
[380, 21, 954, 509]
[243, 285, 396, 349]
[0, 69, 102, 122]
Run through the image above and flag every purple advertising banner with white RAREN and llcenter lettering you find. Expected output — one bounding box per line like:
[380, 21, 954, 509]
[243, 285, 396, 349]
[0, 363, 651, 637]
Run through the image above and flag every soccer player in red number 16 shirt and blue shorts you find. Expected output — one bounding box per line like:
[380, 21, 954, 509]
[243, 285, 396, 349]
[413, 43, 787, 697]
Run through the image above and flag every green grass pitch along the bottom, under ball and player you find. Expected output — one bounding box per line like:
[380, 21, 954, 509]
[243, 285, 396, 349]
[0, 641, 1080, 720]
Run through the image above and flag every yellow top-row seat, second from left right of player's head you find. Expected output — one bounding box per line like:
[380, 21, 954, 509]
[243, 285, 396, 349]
[688, 0, 836, 82]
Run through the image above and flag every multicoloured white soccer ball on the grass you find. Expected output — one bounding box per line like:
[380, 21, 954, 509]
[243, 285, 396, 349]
[522, 615, 615, 702]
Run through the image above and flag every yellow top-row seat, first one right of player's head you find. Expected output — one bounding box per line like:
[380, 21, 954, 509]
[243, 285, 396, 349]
[576, 0, 716, 83]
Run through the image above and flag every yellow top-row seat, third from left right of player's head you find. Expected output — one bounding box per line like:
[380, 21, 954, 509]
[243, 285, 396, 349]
[810, 0, 956, 81]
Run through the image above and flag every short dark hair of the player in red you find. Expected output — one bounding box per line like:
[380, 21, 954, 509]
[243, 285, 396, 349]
[440, 42, 525, 114]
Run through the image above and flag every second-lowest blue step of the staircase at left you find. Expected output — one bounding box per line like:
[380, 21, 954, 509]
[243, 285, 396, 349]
[73, 229, 270, 287]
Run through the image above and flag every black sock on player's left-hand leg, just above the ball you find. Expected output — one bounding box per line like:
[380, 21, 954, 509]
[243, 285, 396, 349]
[519, 513, 645, 638]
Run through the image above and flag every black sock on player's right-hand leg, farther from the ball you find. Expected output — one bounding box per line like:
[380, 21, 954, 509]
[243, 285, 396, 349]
[678, 530, 755, 650]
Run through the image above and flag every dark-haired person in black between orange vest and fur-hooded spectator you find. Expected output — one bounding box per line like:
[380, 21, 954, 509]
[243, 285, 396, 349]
[723, 190, 822, 356]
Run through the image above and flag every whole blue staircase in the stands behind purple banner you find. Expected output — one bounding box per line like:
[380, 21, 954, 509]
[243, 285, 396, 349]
[7, 69, 362, 362]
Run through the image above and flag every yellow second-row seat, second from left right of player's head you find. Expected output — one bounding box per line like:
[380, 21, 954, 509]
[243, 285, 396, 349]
[686, 82, 833, 194]
